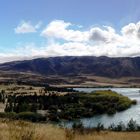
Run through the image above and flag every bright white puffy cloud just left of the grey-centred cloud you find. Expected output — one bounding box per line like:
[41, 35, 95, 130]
[41, 20, 88, 42]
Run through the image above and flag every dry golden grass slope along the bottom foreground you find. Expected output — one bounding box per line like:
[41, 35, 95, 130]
[0, 120, 140, 140]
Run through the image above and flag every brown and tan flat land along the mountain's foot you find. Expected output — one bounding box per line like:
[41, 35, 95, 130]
[0, 71, 140, 87]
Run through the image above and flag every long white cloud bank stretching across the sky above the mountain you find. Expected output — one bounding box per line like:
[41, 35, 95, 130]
[0, 20, 140, 62]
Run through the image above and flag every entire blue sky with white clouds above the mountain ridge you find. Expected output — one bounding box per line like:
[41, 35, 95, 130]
[0, 0, 140, 63]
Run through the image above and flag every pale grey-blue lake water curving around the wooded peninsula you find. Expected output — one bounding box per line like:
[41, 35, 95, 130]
[61, 88, 140, 127]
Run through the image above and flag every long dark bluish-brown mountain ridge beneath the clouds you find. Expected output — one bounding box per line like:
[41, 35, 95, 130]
[0, 56, 140, 78]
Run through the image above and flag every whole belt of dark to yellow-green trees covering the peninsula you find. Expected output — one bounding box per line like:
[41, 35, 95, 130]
[5, 90, 135, 121]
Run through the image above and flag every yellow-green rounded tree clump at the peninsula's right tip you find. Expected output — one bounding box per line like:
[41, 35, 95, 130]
[83, 90, 136, 114]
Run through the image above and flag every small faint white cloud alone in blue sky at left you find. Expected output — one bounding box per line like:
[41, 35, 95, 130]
[14, 21, 42, 34]
